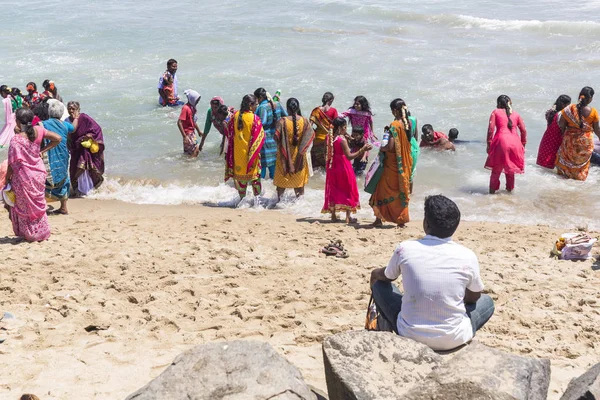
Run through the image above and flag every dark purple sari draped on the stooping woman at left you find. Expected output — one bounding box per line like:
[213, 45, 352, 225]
[68, 113, 104, 191]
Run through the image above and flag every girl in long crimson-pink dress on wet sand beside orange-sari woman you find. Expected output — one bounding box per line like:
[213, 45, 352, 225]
[321, 118, 372, 224]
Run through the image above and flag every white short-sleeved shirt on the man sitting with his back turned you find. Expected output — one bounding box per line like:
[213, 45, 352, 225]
[385, 235, 483, 350]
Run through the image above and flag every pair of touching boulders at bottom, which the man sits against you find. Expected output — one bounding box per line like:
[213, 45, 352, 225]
[323, 330, 550, 400]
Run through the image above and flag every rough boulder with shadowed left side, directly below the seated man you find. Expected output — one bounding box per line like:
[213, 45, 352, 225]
[323, 331, 442, 400]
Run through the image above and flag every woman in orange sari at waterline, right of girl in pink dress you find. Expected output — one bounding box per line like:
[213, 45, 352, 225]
[369, 99, 413, 227]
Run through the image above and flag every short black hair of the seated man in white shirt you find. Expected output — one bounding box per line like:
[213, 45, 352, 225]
[425, 194, 460, 238]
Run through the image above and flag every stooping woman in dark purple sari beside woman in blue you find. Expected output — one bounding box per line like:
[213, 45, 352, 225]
[67, 101, 104, 195]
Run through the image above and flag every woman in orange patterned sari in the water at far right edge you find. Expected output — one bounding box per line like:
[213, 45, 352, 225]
[556, 86, 600, 181]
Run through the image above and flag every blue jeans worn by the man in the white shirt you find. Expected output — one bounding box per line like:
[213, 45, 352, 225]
[372, 281, 494, 335]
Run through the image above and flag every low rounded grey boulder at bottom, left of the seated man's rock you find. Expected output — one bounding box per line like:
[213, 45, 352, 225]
[126, 341, 316, 400]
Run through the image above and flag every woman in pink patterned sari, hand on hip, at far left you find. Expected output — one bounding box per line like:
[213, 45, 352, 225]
[5, 108, 61, 242]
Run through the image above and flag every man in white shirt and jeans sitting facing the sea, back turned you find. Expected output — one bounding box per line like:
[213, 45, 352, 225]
[371, 195, 494, 350]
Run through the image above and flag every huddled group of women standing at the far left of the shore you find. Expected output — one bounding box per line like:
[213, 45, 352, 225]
[0, 80, 104, 241]
